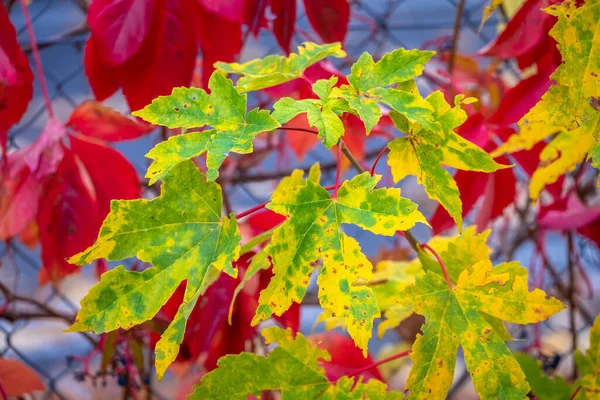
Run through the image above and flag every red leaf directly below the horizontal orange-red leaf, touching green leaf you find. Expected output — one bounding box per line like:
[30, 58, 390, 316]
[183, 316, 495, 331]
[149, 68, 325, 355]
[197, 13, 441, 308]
[69, 136, 141, 220]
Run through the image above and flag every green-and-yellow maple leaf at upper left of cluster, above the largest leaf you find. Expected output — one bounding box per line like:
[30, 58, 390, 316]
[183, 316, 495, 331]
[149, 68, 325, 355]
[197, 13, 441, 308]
[133, 72, 280, 184]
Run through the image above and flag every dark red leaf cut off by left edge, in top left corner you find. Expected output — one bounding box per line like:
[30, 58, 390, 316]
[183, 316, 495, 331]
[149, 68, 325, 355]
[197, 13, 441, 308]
[0, 4, 33, 153]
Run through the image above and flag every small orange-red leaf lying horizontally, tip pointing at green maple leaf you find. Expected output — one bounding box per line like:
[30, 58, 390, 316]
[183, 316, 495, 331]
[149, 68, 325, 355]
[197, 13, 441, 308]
[67, 100, 153, 142]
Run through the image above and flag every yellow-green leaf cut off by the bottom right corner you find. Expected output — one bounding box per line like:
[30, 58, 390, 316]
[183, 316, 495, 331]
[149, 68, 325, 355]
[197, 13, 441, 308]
[572, 316, 600, 400]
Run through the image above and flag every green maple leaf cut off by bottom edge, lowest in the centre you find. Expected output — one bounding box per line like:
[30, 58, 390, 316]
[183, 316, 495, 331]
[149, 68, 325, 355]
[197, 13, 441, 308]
[189, 327, 403, 400]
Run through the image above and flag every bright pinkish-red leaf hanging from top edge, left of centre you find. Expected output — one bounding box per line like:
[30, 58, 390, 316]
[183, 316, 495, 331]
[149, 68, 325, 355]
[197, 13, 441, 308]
[87, 0, 156, 66]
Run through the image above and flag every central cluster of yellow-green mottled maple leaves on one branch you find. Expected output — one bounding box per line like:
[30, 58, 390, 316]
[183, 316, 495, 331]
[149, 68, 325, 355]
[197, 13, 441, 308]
[62, 39, 562, 398]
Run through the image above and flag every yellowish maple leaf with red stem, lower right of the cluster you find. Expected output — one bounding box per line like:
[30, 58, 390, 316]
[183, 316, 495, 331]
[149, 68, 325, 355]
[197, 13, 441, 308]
[398, 233, 564, 399]
